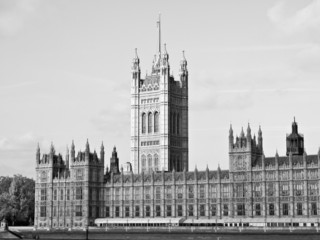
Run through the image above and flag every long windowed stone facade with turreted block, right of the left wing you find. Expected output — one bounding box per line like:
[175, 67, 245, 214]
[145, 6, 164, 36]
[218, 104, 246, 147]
[104, 122, 320, 223]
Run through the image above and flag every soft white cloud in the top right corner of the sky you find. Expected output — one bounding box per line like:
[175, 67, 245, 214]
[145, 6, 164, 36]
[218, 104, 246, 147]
[267, 0, 320, 37]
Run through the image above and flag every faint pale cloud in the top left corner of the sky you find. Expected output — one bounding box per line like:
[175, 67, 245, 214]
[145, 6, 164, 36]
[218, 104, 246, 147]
[0, 0, 38, 36]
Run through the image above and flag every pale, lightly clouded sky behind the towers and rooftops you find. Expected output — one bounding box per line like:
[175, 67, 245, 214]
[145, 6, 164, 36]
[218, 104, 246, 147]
[0, 0, 320, 178]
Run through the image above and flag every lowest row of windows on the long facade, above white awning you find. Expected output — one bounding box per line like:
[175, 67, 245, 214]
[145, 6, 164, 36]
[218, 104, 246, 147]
[105, 203, 317, 217]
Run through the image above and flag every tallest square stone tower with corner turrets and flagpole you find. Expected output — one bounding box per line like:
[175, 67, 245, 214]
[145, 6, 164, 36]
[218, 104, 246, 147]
[131, 18, 188, 173]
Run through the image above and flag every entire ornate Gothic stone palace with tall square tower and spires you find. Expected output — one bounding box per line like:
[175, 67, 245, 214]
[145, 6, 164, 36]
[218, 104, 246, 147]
[35, 22, 320, 229]
